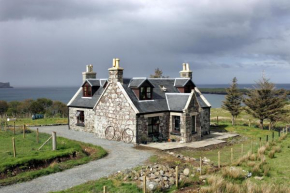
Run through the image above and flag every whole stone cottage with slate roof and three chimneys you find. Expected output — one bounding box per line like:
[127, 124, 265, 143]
[67, 59, 211, 143]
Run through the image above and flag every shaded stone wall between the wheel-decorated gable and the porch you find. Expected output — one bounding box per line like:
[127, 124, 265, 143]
[137, 112, 170, 143]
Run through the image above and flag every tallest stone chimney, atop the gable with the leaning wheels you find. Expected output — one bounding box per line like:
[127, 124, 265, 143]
[108, 58, 124, 84]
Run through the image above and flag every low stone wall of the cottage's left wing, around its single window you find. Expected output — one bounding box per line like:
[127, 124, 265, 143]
[69, 107, 95, 132]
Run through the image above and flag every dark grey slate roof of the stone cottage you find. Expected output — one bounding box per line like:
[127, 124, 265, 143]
[68, 78, 210, 113]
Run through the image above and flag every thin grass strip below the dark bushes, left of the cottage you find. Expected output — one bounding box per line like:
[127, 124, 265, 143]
[0, 118, 68, 127]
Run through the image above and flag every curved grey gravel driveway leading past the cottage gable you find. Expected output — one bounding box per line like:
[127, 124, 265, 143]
[0, 126, 152, 193]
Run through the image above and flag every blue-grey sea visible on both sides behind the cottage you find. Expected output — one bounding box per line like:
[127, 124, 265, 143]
[0, 84, 290, 108]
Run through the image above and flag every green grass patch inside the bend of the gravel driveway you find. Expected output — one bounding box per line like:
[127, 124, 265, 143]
[0, 127, 107, 185]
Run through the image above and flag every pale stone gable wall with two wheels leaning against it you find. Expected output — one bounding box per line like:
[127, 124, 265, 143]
[94, 83, 136, 143]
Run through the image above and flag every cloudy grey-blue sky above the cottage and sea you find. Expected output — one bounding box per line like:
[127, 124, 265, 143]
[0, 0, 290, 87]
